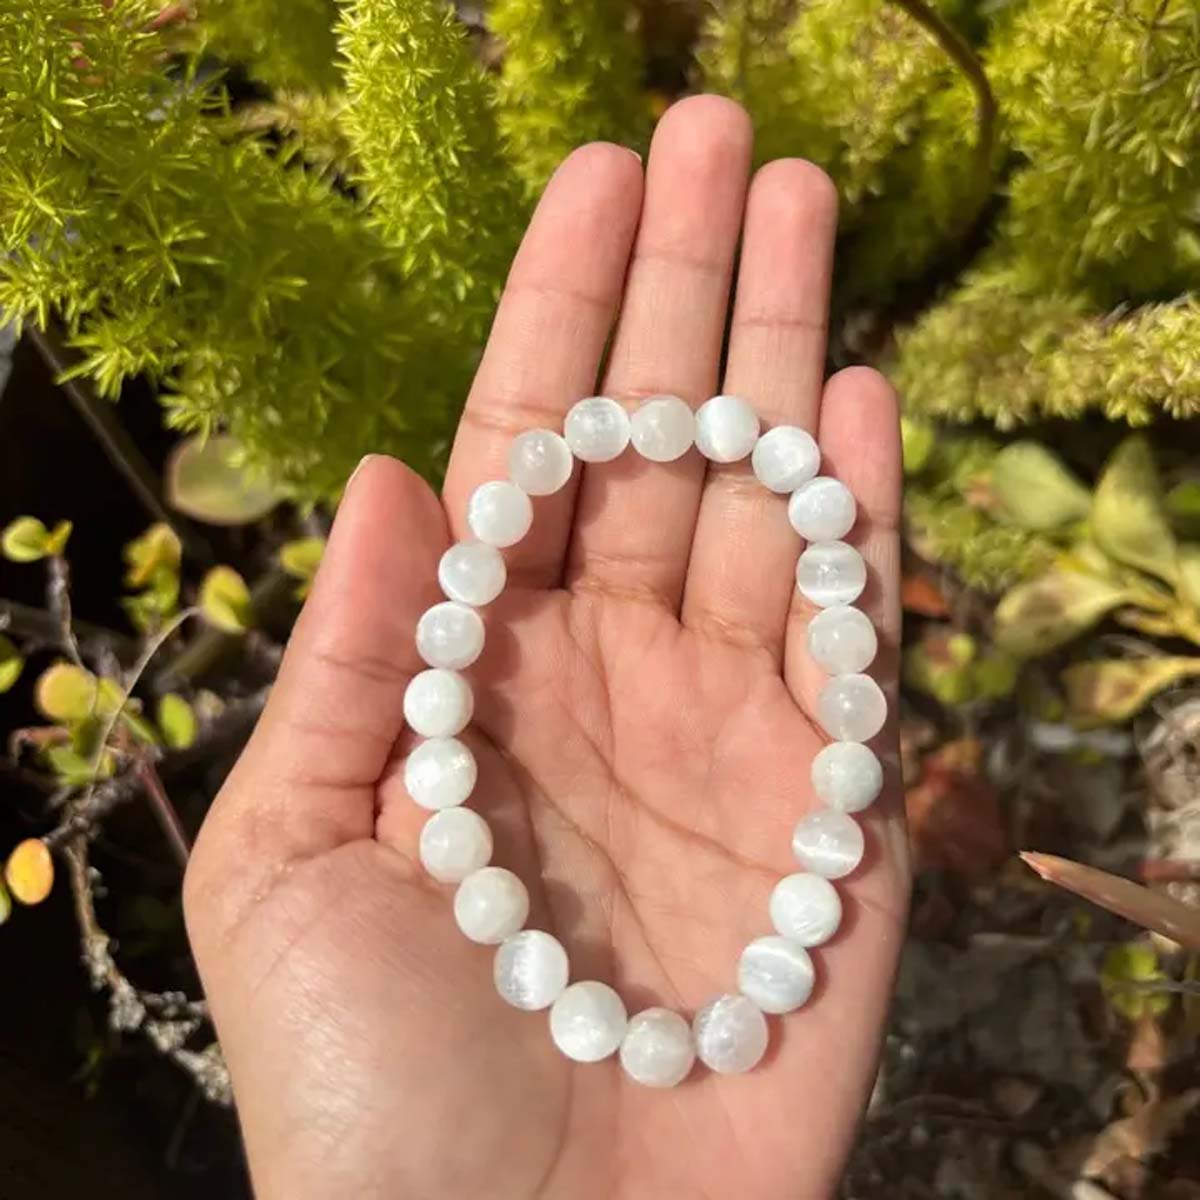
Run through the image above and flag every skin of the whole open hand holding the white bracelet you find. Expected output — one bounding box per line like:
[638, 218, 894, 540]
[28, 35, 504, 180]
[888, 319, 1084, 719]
[185, 96, 908, 1200]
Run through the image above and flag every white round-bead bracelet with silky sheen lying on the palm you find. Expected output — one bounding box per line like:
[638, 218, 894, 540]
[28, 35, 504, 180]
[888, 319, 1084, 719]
[404, 396, 887, 1087]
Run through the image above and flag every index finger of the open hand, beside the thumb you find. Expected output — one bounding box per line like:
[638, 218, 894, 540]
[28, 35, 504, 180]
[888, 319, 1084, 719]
[443, 143, 642, 587]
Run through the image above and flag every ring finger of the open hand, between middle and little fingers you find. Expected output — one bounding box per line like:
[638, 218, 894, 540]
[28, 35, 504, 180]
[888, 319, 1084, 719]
[683, 158, 838, 662]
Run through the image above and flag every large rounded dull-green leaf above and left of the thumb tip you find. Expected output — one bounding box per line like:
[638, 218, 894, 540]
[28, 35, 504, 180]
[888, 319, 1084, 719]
[166, 434, 282, 526]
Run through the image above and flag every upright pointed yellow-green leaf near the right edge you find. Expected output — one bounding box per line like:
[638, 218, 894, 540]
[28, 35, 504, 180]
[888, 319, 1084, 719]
[1092, 433, 1178, 583]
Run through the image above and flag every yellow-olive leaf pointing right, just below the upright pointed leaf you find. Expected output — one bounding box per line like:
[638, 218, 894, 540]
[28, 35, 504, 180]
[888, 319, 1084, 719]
[995, 566, 1129, 658]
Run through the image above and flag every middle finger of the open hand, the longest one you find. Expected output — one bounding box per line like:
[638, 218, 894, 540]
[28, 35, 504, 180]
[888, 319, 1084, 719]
[568, 96, 751, 612]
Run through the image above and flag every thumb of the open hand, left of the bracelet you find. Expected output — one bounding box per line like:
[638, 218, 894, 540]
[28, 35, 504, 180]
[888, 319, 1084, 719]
[188, 456, 448, 926]
